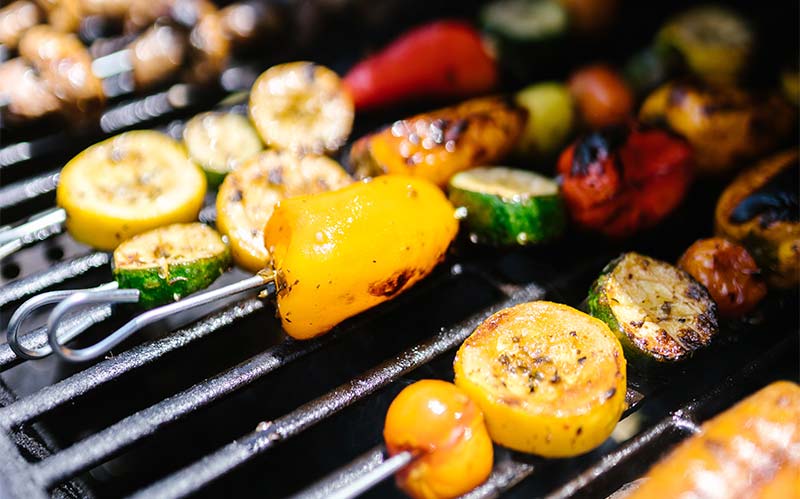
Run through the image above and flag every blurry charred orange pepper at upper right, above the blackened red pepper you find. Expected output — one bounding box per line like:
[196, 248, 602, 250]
[639, 82, 795, 174]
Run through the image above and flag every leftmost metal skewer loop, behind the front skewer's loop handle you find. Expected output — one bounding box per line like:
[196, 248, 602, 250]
[6, 281, 119, 360]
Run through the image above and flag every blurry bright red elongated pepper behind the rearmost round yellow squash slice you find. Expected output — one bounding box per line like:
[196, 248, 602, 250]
[344, 21, 498, 109]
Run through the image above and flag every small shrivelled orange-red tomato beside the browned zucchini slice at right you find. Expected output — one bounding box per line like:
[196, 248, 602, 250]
[678, 237, 767, 317]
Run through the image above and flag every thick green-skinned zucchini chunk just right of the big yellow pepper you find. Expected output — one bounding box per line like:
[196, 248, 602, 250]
[448, 167, 566, 245]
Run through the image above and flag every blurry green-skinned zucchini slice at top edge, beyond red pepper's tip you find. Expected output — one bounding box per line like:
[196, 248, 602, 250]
[481, 0, 569, 43]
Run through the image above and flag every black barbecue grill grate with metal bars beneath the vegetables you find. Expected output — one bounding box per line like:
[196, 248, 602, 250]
[0, 2, 800, 499]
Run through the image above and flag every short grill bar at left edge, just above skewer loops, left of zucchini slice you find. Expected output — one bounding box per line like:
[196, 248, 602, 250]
[0, 251, 111, 307]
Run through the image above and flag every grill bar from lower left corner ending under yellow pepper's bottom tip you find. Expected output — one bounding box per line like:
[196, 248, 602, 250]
[34, 336, 324, 487]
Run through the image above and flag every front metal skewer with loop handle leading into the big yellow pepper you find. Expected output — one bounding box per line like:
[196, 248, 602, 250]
[47, 275, 275, 362]
